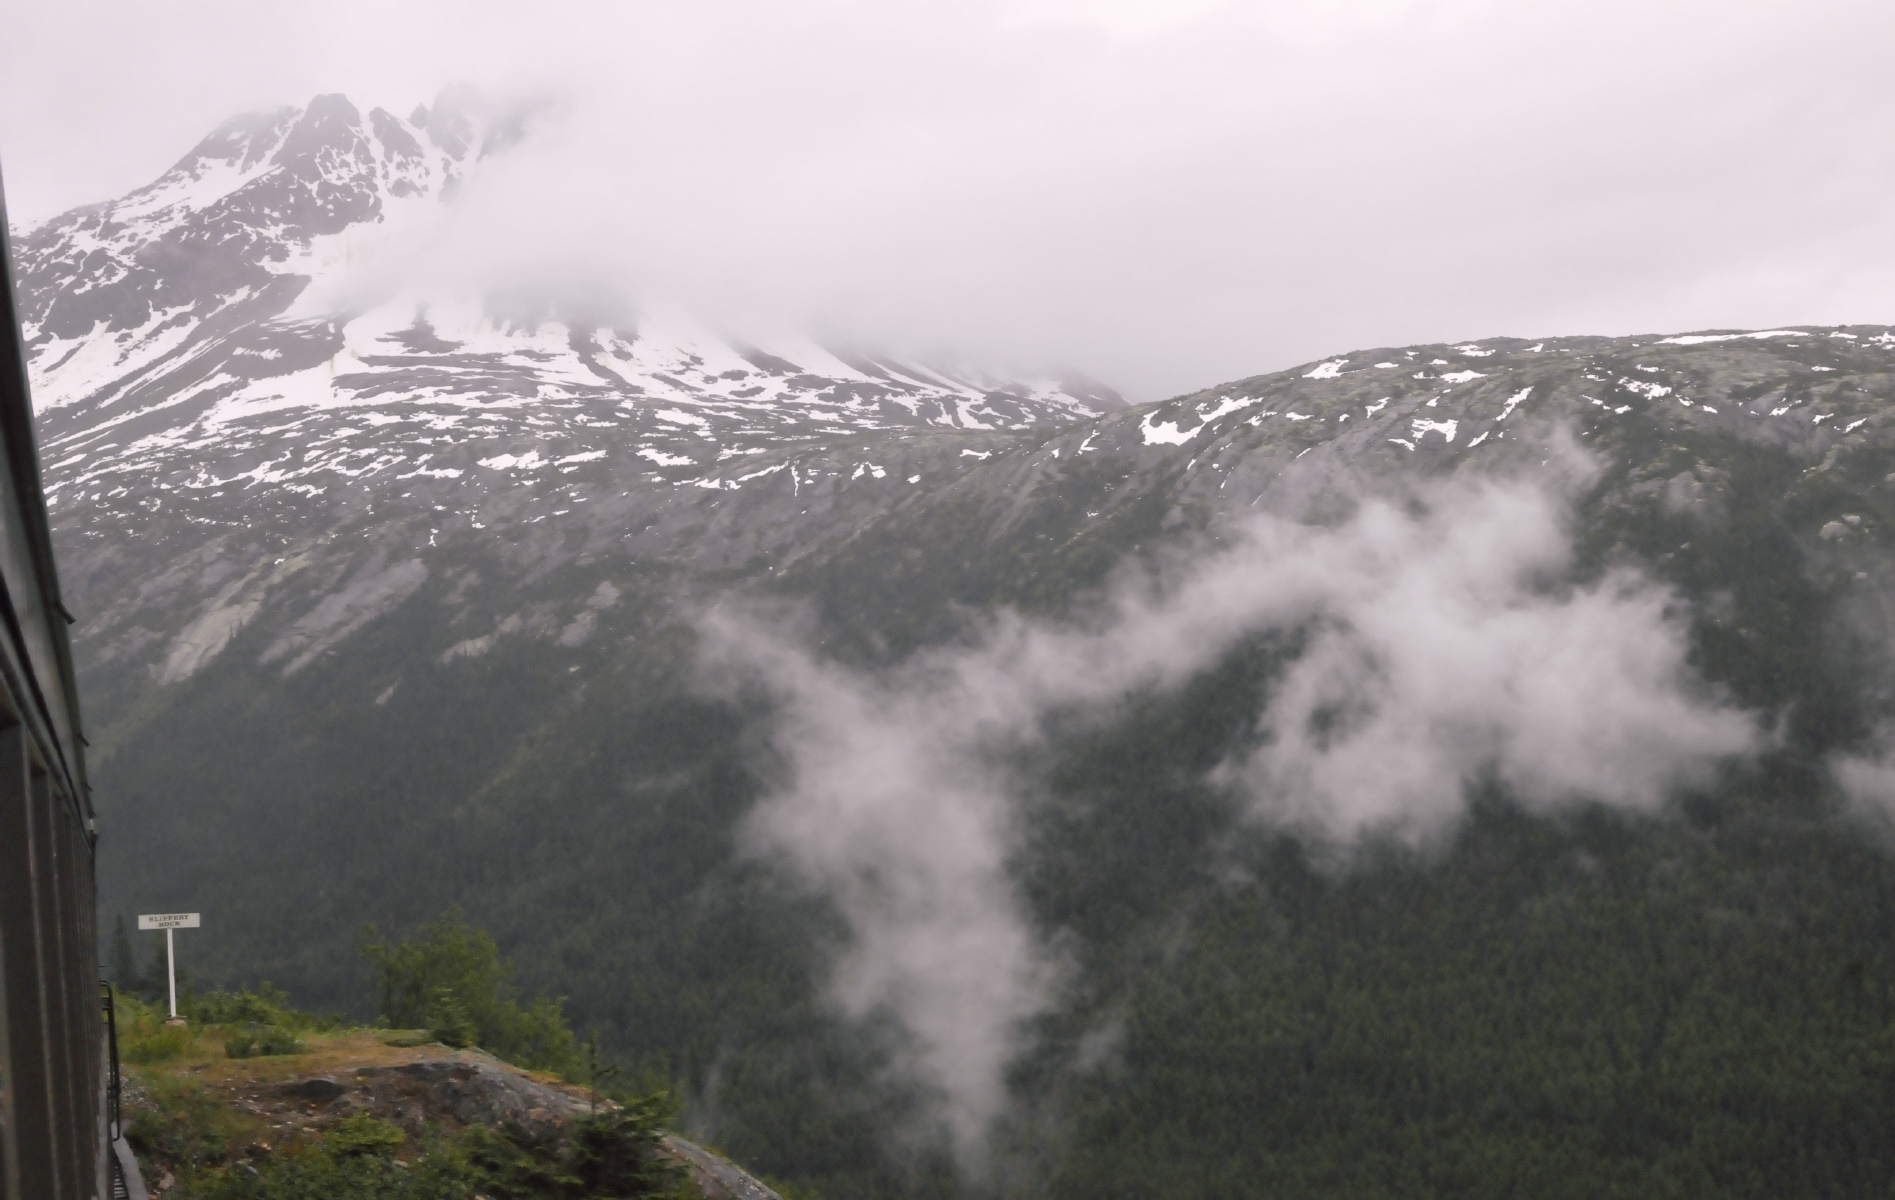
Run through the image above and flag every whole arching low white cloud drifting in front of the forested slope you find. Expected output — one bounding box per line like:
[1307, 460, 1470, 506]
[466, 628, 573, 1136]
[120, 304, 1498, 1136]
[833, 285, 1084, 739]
[705, 460, 1759, 1158]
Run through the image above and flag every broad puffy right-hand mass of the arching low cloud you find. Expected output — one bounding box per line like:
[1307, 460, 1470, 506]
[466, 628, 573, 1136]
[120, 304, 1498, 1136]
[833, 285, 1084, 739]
[1220, 489, 1757, 838]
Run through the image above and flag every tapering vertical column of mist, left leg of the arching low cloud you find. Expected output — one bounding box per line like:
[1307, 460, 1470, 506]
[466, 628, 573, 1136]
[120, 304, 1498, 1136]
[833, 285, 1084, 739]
[707, 614, 1056, 1149]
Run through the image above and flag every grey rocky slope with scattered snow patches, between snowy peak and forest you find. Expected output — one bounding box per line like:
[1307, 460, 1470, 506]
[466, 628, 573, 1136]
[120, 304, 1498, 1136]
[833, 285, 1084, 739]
[47, 328, 1895, 705]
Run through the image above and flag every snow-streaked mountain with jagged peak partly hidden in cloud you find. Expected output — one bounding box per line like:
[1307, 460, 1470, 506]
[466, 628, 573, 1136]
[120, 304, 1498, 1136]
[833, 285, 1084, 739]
[17, 89, 1124, 523]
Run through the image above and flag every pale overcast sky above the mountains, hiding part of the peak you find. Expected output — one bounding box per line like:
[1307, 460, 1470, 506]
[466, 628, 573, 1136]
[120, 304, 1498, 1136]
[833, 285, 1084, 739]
[0, 0, 1895, 398]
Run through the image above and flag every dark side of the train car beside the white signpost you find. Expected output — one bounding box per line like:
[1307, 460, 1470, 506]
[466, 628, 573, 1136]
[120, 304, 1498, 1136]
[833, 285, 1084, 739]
[0, 163, 109, 1200]
